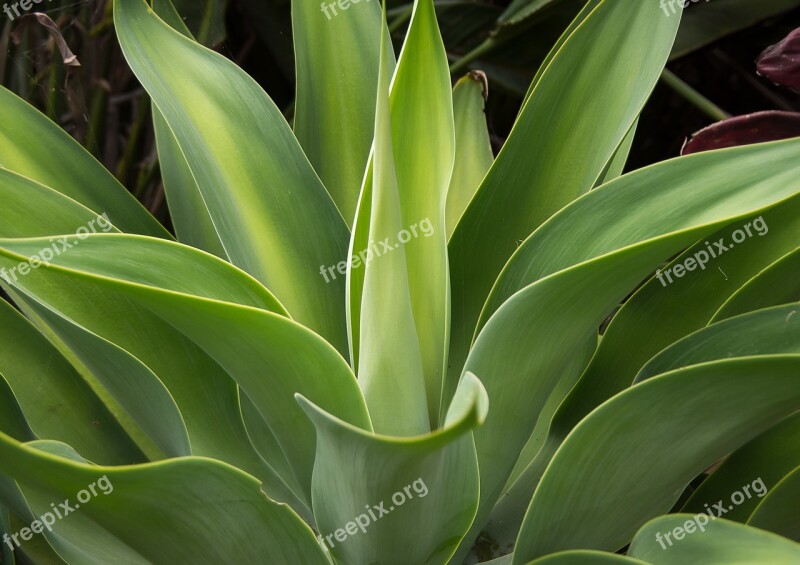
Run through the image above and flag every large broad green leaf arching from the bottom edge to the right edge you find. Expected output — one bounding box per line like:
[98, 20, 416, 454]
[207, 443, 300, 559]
[514, 355, 800, 563]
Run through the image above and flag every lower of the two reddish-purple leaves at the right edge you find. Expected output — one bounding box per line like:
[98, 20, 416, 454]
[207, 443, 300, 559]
[681, 110, 800, 155]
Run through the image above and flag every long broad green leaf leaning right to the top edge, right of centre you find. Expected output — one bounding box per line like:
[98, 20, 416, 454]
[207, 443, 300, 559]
[445, 0, 678, 406]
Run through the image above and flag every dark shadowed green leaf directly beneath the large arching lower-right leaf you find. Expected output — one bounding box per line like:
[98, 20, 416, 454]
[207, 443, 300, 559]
[681, 414, 800, 523]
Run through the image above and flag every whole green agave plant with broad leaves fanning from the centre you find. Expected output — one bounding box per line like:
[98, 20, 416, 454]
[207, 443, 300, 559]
[0, 0, 800, 565]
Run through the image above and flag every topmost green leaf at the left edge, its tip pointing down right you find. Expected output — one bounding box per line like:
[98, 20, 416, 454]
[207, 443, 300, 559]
[0, 87, 170, 238]
